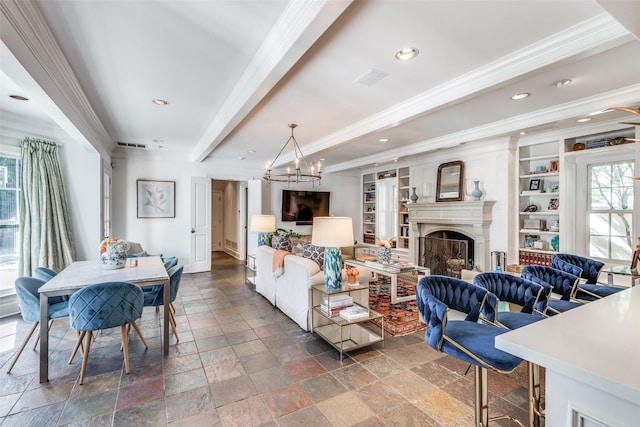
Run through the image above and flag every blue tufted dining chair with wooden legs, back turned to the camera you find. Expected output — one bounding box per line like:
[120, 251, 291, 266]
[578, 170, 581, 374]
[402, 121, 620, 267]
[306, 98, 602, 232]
[69, 282, 143, 384]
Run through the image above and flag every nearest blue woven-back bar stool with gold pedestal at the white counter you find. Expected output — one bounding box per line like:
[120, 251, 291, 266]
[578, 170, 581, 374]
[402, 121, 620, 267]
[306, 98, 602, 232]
[416, 276, 539, 427]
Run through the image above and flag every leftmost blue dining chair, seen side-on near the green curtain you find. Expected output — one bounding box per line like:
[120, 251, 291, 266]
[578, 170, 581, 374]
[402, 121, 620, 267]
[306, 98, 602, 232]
[7, 277, 69, 373]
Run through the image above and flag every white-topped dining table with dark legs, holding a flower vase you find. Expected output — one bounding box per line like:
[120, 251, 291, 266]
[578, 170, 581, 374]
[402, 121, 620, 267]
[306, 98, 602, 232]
[39, 256, 170, 383]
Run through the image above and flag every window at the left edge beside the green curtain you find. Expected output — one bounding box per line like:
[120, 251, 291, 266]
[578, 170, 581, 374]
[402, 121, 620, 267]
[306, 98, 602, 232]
[0, 154, 21, 294]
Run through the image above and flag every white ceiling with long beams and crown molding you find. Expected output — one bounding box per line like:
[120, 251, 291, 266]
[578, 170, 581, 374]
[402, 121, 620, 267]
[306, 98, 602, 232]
[0, 0, 640, 176]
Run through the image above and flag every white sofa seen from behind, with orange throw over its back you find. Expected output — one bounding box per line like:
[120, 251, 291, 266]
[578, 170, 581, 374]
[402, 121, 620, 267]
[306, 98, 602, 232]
[256, 246, 324, 331]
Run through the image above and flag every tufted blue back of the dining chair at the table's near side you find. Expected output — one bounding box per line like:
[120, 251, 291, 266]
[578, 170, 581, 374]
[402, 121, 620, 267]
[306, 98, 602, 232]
[69, 282, 143, 331]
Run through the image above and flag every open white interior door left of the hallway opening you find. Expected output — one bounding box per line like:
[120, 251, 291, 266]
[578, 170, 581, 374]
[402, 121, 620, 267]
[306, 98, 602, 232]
[190, 177, 211, 273]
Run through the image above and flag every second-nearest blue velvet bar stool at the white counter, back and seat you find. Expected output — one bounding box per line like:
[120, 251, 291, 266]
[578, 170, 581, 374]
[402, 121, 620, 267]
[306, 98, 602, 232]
[473, 272, 551, 329]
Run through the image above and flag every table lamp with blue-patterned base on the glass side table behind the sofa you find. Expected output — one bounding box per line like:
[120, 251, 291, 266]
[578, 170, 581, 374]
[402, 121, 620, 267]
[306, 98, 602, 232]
[311, 216, 353, 291]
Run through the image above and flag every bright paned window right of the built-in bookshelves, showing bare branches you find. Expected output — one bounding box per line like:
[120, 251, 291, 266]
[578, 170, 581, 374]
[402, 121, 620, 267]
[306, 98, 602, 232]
[587, 161, 635, 261]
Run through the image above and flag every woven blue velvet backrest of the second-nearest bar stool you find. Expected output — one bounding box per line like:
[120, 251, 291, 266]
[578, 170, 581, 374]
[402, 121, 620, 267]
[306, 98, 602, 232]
[473, 272, 551, 321]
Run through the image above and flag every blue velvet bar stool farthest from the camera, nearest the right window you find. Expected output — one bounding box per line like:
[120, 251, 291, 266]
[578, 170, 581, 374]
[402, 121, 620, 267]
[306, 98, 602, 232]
[551, 254, 623, 301]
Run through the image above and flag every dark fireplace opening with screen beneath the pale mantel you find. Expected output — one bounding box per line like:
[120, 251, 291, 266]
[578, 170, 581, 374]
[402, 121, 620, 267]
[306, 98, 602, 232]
[418, 232, 473, 278]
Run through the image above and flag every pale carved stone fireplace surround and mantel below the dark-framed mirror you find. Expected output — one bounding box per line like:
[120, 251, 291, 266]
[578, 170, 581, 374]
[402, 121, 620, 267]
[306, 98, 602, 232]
[407, 201, 495, 271]
